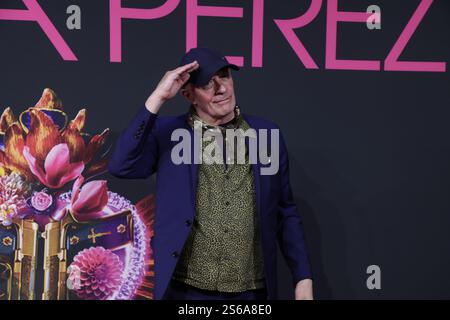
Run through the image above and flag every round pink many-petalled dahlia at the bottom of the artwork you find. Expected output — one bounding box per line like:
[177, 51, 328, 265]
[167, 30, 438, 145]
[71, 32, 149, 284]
[69, 247, 123, 300]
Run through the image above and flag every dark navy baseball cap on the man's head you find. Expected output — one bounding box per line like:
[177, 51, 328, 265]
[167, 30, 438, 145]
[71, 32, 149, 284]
[180, 47, 239, 86]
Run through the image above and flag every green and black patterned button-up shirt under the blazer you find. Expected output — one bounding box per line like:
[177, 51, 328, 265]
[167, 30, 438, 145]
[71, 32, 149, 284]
[173, 109, 265, 292]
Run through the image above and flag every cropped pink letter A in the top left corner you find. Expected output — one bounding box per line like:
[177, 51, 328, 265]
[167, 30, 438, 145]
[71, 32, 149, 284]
[0, 0, 78, 61]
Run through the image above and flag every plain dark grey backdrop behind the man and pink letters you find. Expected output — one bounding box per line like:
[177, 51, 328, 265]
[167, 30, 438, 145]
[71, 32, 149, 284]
[0, 0, 450, 299]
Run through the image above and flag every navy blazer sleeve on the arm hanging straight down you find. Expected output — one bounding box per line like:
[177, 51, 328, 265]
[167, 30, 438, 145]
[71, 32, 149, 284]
[277, 133, 312, 286]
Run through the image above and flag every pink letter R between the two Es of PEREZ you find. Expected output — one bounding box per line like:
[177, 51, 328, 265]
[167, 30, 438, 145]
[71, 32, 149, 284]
[274, 0, 322, 69]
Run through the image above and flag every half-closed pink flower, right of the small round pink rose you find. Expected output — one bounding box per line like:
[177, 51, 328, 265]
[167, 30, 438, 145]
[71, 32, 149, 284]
[70, 175, 108, 221]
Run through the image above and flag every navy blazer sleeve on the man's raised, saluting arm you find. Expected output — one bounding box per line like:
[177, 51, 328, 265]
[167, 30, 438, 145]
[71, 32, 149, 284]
[108, 106, 158, 179]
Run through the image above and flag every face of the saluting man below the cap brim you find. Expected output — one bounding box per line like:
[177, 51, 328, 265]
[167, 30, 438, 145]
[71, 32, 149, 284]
[184, 67, 236, 124]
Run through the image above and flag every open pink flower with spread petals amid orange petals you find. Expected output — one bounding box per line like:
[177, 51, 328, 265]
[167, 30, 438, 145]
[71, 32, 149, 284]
[23, 143, 84, 189]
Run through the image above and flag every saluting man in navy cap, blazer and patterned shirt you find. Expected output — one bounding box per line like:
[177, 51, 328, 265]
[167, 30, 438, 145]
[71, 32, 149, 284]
[109, 48, 313, 300]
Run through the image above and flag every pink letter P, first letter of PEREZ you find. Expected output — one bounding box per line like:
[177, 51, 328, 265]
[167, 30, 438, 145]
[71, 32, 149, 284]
[109, 0, 180, 62]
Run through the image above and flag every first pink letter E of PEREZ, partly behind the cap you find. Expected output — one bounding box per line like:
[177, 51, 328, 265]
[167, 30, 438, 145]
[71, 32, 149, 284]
[186, 0, 244, 67]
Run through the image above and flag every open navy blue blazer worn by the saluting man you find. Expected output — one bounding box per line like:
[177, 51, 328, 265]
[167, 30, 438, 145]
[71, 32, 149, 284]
[108, 106, 312, 300]
